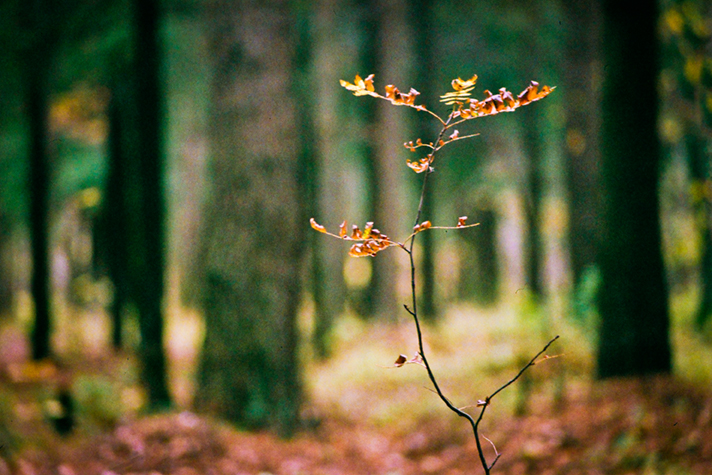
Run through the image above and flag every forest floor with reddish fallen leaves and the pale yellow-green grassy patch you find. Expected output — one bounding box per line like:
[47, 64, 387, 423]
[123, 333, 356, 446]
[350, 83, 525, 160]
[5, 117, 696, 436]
[0, 306, 712, 475]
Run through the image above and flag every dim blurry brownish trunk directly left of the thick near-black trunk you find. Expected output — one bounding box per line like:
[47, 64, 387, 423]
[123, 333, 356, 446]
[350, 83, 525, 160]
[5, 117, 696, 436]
[561, 0, 601, 298]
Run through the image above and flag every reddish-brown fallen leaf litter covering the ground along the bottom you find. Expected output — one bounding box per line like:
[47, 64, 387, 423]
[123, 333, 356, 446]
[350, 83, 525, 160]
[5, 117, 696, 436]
[6, 377, 712, 475]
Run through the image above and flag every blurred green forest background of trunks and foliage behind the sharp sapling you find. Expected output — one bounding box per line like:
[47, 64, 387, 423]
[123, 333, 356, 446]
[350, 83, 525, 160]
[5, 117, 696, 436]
[0, 0, 712, 473]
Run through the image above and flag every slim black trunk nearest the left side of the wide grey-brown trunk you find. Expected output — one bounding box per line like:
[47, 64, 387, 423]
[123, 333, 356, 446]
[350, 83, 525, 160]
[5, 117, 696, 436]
[132, 0, 170, 409]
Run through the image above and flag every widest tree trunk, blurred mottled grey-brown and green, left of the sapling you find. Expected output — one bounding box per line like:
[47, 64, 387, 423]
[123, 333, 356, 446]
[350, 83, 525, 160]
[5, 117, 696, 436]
[196, 1, 308, 435]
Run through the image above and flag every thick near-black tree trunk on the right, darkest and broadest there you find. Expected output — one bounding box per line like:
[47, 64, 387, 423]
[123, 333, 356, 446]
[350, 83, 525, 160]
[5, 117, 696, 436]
[598, 0, 671, 378]
